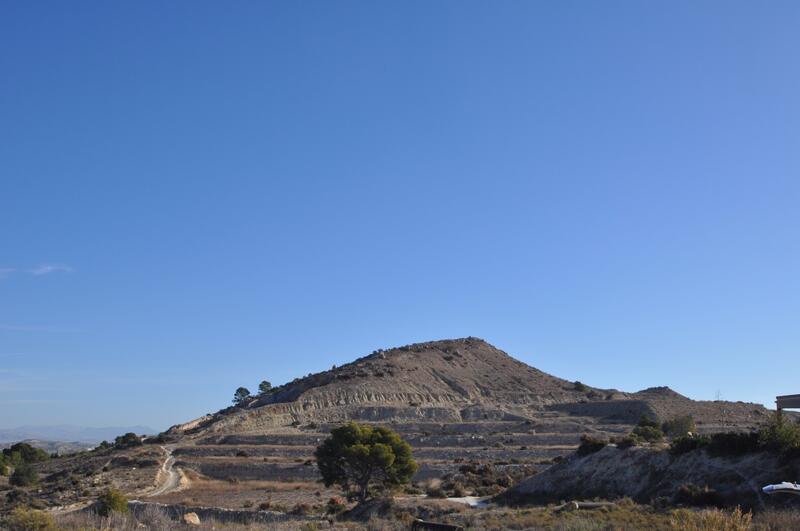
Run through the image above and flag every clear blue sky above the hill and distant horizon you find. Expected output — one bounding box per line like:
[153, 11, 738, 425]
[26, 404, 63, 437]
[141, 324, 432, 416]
[0, 0, 800, 429]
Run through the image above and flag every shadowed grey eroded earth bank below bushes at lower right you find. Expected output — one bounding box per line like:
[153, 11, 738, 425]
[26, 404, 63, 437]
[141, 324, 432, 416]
[503, 446, 800, 508]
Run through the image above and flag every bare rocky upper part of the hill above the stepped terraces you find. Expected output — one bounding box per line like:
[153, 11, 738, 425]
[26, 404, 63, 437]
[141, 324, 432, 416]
[171, 337, 766, 434]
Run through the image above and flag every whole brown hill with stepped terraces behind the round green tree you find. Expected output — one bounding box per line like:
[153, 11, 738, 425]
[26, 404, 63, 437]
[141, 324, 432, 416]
[142, 338, 767, 508]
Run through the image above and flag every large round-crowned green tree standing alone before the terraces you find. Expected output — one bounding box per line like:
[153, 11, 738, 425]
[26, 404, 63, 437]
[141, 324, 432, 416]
[314, 422, 417, 502]
